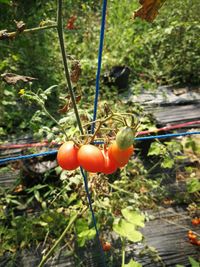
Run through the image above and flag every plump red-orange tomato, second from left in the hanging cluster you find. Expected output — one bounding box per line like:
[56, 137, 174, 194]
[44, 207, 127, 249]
[78, 144, 105, 172]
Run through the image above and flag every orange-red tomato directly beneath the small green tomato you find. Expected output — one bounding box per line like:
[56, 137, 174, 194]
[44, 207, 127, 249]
[108, 142, 134, 167]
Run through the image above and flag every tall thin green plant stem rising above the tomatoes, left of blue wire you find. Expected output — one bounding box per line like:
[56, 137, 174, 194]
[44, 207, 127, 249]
[57, 0, 84, 134]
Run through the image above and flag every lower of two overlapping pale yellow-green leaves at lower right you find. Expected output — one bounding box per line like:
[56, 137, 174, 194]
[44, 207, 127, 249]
[113, 219, 142, 242]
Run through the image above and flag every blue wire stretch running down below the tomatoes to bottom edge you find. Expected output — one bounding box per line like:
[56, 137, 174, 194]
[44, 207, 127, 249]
[80, 168, 106, 266]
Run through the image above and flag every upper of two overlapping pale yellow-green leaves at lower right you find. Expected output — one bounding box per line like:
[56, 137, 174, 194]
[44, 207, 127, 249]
[121, 208, 145, 227]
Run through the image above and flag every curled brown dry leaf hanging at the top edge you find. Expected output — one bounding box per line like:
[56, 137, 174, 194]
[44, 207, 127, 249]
[133, 0, 166, 22]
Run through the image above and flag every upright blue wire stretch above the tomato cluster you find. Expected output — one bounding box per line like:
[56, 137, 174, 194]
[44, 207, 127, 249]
[91, 0, 107, 134]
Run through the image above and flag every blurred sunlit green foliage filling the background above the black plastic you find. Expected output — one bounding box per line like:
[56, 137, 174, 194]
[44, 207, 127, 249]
[0, 0, 200, 138]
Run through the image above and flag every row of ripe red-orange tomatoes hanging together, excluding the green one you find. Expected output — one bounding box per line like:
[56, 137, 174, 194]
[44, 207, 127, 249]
[57, 141, 133, 174]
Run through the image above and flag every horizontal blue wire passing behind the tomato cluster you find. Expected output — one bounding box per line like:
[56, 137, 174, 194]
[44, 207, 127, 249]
[0, 131, 200, 165]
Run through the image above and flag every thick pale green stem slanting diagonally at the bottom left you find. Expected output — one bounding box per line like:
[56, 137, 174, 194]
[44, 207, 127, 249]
[38, 207, 87, 267]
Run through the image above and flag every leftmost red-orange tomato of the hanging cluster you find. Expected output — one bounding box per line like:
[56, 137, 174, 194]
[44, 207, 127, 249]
[57, 141, 79, 170]
